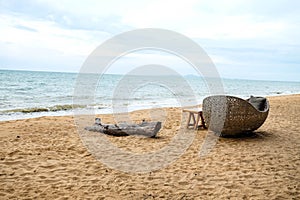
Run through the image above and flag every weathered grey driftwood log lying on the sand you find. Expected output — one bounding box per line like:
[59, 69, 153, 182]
[85, 118, 161, 137]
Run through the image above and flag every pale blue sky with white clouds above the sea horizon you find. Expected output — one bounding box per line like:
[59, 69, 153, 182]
[0, 0, 300, 81]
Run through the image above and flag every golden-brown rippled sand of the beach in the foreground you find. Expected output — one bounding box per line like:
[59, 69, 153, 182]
[0, 95, 300, 199]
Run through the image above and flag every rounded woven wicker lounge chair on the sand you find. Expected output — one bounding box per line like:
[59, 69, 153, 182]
[202, 95, 269, 136]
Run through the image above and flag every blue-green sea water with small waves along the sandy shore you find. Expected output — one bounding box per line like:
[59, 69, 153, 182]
[0, 70, 300, 121]
